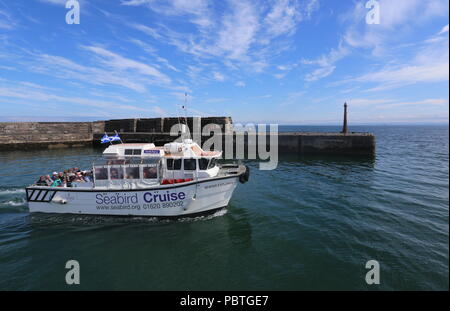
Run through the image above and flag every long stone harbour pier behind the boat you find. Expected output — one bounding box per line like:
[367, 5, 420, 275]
[0, 117, 375, 155]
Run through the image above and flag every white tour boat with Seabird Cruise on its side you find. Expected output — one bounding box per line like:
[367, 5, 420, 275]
[26, 139, 249, 217]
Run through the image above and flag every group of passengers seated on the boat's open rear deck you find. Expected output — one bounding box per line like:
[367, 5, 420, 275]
[36, 167, 92, 187]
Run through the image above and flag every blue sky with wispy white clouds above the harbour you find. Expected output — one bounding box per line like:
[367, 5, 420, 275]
[0, 0, 449, 124]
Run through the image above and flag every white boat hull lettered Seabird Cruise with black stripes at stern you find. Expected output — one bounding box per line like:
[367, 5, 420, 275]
[26, 176, 239, 217]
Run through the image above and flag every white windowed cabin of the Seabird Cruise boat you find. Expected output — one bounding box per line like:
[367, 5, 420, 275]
[93, 139, 222, 189]
